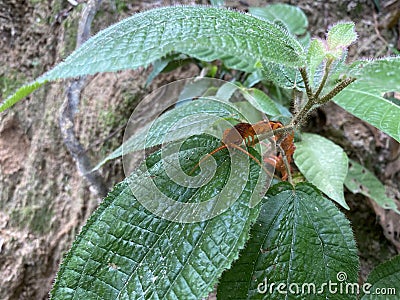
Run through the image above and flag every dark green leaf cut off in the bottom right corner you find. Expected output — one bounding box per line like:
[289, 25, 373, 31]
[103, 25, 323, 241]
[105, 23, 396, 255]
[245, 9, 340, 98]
[361, 255, 400, 300]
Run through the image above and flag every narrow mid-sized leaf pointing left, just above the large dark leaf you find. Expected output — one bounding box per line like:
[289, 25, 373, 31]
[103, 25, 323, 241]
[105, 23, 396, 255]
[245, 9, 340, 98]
[93, 97, 244, 171]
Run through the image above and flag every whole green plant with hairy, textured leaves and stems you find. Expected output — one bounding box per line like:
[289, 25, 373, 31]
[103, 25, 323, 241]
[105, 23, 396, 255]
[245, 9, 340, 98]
[0, 1, 400, 299]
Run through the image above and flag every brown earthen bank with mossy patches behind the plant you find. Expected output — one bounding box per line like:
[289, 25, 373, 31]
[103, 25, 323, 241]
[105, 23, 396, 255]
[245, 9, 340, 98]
[0, 0, 400, 300]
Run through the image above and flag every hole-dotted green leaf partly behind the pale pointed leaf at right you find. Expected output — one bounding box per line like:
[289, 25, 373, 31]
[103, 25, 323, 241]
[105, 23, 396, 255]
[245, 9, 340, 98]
[344, 160, 400, 214]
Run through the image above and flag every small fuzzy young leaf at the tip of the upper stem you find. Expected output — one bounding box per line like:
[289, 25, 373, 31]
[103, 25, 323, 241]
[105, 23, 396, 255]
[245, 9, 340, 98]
[326, 22, 357, 54]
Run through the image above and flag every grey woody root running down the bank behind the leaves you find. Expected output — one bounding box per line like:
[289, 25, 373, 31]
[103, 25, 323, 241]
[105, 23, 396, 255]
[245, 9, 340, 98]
[59, 0, 108, 197]
